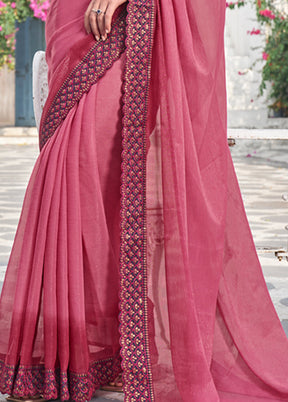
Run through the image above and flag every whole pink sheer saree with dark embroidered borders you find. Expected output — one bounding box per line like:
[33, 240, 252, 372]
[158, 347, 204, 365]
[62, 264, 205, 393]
[0, 0, 288, 402]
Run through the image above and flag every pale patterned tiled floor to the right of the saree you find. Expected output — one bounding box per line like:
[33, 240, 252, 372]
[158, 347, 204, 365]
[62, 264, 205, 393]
[232, 140, 288, 326]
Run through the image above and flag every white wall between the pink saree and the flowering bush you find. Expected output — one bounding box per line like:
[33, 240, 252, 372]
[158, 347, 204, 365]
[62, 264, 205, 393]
[225, 4, 288, 128]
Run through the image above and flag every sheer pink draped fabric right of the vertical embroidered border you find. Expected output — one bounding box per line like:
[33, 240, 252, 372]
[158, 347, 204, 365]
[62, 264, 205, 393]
[148, 0, 288, 402]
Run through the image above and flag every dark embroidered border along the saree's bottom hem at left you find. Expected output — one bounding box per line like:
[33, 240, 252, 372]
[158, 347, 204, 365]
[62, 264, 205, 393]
[0, 355, 121, 402]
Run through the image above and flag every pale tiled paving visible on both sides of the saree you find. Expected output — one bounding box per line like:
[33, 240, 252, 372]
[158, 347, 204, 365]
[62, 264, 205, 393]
[0, 140, 288, 402]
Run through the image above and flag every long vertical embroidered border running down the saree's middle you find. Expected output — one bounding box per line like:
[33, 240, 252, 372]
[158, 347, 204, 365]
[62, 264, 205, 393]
[120, 0, 155, 402]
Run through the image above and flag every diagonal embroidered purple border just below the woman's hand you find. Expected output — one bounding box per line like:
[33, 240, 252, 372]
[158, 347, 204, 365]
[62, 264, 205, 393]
[40, 10, 126, 149]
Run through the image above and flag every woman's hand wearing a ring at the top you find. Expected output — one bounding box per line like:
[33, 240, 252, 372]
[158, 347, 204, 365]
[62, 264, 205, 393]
[84, 0, 127, 41]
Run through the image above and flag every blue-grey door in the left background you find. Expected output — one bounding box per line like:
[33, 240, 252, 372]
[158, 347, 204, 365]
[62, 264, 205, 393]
[15, 18, 45, 127]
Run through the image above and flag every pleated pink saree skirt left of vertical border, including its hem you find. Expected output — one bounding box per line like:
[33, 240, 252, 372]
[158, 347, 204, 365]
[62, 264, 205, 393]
[0, 55, 123, 400]
